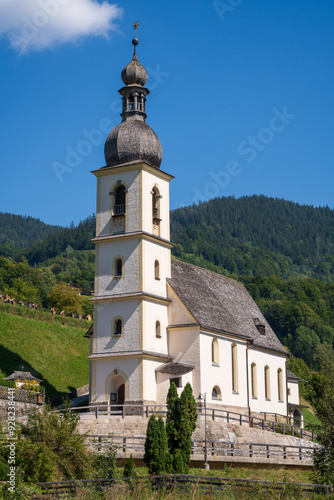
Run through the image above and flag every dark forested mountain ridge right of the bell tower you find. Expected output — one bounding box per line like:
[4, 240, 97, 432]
[171, 196, 334, 281]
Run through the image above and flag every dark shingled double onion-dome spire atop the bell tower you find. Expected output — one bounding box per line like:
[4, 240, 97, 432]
[104, 32, 162, 168]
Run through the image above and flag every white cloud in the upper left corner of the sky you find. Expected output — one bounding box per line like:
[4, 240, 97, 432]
[0, 0, 123, 54]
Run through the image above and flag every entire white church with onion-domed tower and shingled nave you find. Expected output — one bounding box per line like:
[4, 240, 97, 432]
[88, 32, 300, 422]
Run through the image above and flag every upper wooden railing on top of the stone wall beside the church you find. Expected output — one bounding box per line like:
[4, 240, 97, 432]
[72, 404, 317, 441]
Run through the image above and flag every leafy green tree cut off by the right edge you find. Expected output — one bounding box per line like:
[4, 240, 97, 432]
[313, 373, 334, 484]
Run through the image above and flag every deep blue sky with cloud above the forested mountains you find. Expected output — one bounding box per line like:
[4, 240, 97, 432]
[0, 0, 334, 225]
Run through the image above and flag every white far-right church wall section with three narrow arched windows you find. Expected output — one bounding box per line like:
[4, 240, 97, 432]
[248, 348, 287, 415]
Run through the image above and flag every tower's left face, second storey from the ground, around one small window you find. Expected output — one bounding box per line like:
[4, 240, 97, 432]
[94, 299, 140, 353]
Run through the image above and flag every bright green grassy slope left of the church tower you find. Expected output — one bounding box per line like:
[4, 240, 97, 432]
[0, 312, 89, 399]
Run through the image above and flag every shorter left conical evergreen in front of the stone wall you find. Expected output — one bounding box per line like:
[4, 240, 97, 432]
[144, 415, 169, 474]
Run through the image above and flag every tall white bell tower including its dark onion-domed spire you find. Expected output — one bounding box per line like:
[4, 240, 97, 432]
[90, 27, 173, 405]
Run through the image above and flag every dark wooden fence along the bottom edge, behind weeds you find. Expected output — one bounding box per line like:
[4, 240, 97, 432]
[31, 474, 334, 499]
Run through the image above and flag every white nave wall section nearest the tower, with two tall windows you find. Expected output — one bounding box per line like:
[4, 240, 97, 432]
[200, 331, 247, 407]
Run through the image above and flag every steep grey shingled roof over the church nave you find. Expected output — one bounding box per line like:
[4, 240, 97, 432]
[168, 259, 287, 354]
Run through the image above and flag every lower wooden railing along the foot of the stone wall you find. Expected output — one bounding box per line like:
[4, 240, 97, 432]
[86, 435, 314, 462]
